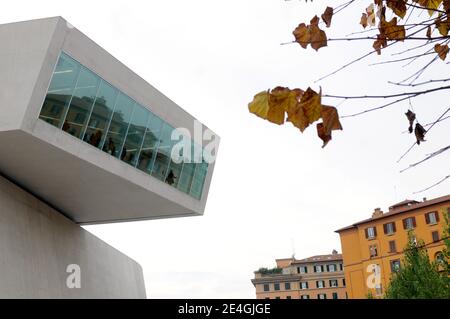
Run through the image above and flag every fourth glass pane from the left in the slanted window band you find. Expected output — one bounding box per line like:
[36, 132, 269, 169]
[103, 93, 135, 157]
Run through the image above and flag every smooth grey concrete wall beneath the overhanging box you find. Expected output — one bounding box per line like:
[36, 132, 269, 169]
[0, 176, 146, 298]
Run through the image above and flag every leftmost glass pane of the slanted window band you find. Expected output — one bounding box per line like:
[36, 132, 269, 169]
[39, 54, 80, 127]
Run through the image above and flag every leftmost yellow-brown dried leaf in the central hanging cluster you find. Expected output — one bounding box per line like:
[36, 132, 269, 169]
[248, 91, 285, 124]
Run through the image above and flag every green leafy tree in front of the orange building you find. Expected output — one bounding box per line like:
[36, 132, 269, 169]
[385, 229, 450, 299]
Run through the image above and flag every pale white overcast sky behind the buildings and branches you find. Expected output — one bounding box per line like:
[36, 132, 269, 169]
[0, 0, 450, 298]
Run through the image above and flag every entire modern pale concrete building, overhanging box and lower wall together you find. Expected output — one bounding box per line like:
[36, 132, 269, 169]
[0, 17, 218, 298]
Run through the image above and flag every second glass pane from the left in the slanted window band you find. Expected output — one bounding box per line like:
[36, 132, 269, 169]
[62, 68, 100, 138]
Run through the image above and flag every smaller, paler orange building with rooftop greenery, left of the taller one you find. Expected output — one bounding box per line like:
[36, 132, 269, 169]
[252, 251, 347, 299]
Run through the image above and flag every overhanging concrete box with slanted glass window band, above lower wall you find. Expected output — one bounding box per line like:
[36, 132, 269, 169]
[0, 17, 218, 224]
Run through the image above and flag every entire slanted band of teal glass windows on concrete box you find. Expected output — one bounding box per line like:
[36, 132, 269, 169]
[39, 53, 208, 199]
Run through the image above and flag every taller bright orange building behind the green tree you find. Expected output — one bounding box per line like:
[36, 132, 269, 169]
[336, 195, 450, 299]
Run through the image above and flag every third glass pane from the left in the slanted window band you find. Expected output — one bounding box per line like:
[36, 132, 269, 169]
[83, 81, 118, 148]
